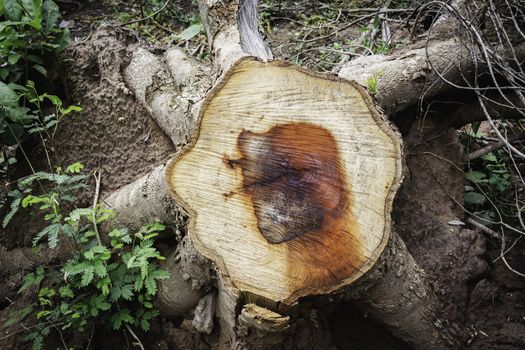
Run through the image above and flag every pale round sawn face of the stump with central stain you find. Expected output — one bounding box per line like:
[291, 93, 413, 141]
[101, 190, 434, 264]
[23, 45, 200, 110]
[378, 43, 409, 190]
[166, 59, 401, 304]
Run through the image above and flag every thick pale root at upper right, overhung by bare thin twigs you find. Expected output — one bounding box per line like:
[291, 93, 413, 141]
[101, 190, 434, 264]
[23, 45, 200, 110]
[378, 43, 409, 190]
[339, 0, 525, 126]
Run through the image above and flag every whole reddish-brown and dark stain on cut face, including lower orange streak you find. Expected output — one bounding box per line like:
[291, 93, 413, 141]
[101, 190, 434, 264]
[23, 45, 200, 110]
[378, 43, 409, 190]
[228, 123, 364, 288]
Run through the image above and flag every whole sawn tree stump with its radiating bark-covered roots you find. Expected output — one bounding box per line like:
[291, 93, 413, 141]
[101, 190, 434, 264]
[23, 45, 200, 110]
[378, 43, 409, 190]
[99, 0, 524, 349]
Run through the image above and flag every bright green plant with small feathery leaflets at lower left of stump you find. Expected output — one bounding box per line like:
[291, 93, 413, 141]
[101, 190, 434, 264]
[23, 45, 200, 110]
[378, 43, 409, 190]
[3, 163, 169, 349]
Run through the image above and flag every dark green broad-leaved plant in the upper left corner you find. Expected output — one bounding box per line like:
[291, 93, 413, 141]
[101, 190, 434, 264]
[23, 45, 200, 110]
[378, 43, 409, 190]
[0, 0, 74, 173]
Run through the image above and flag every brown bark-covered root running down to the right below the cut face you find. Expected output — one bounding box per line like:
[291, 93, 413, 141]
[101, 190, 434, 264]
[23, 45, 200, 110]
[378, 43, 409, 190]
[345, 233, 461, 349]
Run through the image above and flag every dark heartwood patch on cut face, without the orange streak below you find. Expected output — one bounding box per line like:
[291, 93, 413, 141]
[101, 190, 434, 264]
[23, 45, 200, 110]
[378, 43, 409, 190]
[234, 123, 348, 243]
